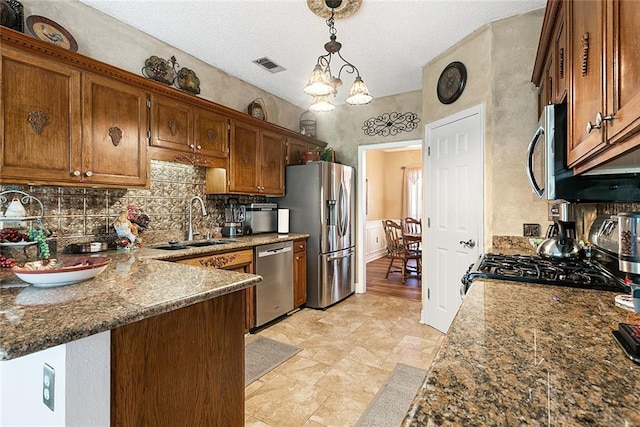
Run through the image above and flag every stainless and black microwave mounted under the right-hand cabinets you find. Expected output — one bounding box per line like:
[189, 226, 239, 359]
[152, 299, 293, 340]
[527, 103, 640, 202]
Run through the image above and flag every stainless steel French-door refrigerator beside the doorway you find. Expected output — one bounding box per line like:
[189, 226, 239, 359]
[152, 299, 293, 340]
[278, 162, 355, 308]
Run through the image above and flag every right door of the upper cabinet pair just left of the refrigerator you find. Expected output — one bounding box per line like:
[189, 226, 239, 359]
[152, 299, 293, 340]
[260, 130, 286, 196]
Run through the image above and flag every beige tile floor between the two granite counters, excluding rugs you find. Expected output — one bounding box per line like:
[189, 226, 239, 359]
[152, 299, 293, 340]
[245, 294, 443, 427]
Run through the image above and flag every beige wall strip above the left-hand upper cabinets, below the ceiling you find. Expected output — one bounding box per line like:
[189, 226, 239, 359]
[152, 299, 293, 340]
[21, 0, 304, 131]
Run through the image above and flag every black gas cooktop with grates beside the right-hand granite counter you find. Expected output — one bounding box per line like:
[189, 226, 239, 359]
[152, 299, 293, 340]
[462, 254, 629, 293]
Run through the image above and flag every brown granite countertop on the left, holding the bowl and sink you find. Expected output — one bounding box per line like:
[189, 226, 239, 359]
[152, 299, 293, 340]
[0, 234, 308, 361]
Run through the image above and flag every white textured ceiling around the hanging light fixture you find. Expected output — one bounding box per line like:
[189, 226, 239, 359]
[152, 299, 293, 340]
[80, 0, 546, 108]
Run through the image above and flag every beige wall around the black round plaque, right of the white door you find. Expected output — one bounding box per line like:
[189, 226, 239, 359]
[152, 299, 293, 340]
[422, 9, 547, 248]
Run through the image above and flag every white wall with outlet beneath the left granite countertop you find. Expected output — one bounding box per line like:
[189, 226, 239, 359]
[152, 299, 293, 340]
[0, 332, 111, 427]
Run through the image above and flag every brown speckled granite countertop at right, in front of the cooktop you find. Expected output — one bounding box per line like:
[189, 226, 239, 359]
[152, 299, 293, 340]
[403, 279, 640, 426]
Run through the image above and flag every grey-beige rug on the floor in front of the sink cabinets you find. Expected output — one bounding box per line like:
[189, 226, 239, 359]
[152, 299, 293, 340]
[244, 337, 302, 387]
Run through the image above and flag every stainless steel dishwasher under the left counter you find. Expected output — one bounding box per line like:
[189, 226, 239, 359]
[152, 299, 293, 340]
[255, 241, 293, 327]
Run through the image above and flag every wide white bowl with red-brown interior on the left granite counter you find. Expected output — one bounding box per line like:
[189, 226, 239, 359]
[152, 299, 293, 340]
[12, 256, 111, 288]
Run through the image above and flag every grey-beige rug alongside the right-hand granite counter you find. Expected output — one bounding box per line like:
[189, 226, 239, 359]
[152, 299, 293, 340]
[356, 363, 427, 427]
